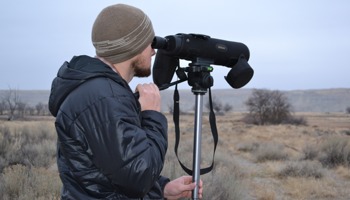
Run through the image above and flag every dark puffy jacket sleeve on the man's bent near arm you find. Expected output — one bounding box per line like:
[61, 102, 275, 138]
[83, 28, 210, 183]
[81, 91, 167, 198]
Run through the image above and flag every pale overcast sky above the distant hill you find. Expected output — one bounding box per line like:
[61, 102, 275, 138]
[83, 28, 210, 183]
[0, 0, 350, 90]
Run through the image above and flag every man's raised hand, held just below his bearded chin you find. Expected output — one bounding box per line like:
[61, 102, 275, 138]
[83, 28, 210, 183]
[136, 83, 160, 112]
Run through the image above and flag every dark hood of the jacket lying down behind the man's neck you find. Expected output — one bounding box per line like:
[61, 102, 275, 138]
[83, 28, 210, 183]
[49, 56, 127, 117]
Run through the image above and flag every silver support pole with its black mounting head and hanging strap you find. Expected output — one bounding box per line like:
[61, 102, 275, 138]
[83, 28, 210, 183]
[173, 59, 218, 199]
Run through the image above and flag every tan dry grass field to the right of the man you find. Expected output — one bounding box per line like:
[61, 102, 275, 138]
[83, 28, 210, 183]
[164, 113, 350, 200]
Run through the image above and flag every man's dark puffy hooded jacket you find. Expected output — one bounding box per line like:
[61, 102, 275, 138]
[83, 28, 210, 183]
[49, 56, 169, 200]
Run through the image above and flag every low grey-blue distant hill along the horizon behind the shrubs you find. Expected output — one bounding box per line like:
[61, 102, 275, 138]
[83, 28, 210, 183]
[0, 88, 350, 112]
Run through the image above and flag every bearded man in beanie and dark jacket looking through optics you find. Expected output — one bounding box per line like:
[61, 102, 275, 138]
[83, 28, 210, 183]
[49, 4, 202, 200]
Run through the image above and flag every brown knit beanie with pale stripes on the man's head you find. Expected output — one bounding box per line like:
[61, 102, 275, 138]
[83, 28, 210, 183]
[91, 4, 154, 64]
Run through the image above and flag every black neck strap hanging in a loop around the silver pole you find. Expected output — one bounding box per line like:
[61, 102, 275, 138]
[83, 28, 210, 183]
[173, 85, 219, 175]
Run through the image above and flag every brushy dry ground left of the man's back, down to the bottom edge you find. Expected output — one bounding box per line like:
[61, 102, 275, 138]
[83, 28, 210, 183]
[0, 122, 62, 200]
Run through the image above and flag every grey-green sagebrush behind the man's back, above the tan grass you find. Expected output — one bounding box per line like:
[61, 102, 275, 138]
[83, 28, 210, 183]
[0, 124, 56, 172]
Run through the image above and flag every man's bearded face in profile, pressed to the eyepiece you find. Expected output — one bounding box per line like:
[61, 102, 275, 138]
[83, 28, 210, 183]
[132, 45, 155, 77]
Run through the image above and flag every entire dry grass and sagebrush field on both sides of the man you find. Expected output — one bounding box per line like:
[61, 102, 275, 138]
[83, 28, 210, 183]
[0, 113, 350, 200]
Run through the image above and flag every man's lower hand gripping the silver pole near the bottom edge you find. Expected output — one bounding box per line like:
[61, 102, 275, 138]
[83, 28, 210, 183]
[164, 176, 203, 200]
